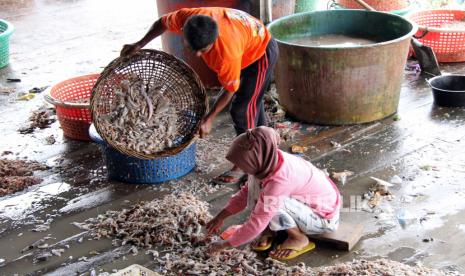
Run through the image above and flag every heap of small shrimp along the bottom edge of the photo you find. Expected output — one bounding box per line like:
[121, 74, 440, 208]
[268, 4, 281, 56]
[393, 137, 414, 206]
[154, 247, 449, 276]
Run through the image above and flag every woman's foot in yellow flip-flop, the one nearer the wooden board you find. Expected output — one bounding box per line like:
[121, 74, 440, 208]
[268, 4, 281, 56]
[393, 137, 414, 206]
[270, 227, 315, 260]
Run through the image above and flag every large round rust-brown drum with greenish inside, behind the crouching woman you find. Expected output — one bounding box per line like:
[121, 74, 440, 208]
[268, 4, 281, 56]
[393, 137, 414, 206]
[268, 10, 417, 125]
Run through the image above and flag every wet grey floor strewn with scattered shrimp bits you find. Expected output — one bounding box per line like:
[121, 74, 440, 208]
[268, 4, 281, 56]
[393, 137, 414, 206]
[0, 0, 465, 275]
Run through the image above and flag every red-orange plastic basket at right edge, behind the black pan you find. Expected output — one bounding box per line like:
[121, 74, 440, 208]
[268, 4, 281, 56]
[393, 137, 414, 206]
[408, 10, 465, 62]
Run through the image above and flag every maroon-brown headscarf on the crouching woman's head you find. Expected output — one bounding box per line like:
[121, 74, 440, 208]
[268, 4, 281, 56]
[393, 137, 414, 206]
[226, 126, 280, 179]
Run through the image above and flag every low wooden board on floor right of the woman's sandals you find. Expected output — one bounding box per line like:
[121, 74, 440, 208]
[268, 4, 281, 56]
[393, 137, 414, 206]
[310, 223, 363, 251]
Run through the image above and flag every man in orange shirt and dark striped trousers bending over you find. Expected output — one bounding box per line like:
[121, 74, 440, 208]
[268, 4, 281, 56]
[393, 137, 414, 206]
[121, 7, 278, 183]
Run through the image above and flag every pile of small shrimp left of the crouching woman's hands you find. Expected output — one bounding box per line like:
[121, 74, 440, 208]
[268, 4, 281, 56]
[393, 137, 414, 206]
[74, 193, 211, 248]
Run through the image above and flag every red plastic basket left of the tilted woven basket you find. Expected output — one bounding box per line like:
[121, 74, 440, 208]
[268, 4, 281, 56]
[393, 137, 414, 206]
[45, 74, 100, 141]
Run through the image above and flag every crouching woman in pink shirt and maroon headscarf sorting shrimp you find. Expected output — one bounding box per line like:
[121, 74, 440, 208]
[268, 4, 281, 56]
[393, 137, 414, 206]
[207, 127, 341, 260]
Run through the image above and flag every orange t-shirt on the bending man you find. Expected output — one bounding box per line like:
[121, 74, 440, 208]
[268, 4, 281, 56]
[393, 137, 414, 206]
[161, 8, 271, 92]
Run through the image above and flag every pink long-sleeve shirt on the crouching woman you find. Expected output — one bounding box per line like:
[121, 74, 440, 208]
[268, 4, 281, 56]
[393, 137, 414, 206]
[225, 150, 341, 247]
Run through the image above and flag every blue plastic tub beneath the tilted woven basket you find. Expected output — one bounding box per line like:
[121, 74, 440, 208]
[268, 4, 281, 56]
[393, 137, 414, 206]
[89, 125, 196, 184]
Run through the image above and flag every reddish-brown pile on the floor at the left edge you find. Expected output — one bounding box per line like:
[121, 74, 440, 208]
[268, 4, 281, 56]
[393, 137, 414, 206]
[0, 159, 48, 196]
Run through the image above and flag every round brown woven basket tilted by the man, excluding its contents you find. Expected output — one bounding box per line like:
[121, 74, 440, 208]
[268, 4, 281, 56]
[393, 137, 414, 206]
[90, 50, 208, 159]
